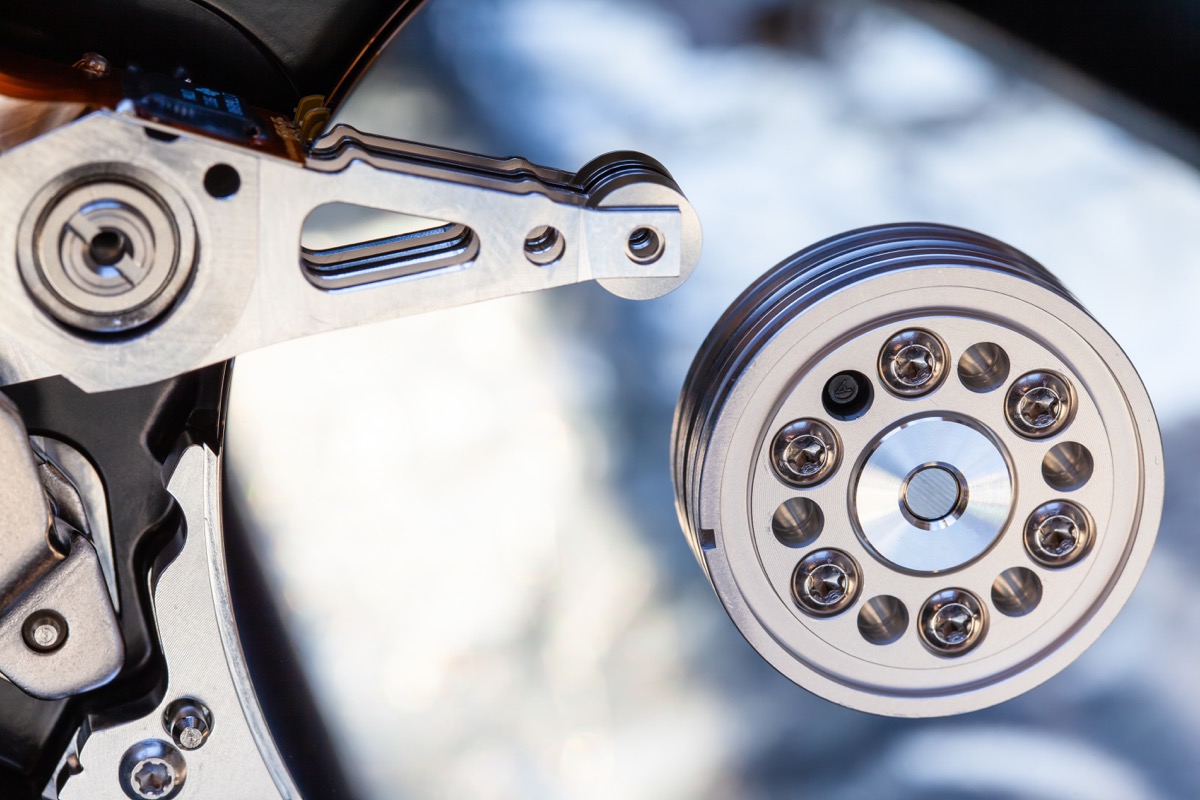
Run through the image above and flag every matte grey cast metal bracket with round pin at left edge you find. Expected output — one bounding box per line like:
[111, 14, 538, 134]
[0, 396, 125, 699]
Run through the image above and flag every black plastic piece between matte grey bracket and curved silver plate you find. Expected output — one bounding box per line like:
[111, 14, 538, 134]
[0, 363, 229, 800]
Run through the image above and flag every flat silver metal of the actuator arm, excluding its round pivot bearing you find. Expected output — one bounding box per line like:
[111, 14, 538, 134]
[0, 113, 700, 391]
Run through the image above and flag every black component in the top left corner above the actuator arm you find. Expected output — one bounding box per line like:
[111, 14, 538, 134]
[0, 0, 424, 112]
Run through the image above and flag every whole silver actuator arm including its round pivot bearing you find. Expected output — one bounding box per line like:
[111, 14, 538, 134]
[0, 112, 701, 391]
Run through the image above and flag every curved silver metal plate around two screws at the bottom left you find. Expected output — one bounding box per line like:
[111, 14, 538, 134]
[60, 445, 298, 800]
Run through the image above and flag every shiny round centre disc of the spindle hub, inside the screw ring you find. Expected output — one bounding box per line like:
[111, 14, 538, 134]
[850, 416, 1014, 572]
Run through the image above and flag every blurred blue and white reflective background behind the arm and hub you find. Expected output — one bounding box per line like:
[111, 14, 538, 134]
[228, 0, 1200, 800]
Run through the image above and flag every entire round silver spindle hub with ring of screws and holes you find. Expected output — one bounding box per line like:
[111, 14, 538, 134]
[673, 224, 1163, 716]
